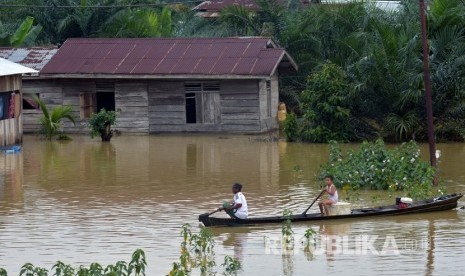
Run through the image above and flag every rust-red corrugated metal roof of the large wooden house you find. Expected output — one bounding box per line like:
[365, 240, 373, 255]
[41, 37, 297, 77]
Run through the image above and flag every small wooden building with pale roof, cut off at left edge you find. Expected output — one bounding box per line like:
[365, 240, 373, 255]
[0, 58, 37, 146]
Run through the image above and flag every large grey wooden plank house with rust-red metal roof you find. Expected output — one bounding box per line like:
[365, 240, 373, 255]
[38, 37, 297, 133]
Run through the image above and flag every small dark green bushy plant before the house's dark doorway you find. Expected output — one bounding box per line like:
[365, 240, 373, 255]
[89, 108, 116, 141]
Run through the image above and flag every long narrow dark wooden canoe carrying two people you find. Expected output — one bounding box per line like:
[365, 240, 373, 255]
[199, 194, 463, 226]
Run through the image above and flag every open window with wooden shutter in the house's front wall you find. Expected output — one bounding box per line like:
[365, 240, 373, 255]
[184, 82, 220, 124]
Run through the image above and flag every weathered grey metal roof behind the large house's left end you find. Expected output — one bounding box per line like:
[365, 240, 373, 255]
[0, 47, 58, 71]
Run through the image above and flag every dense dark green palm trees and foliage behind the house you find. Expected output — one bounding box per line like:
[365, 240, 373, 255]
[0, 0, 465, 142]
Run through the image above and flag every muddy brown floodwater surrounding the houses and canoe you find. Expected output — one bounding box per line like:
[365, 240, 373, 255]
[0, 135, 465, 275]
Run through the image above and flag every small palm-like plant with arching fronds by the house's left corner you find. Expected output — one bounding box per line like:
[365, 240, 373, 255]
[32, 95, 76, 140]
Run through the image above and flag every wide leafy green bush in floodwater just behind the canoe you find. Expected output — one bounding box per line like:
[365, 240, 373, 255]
[319, 139, 435, 198]
